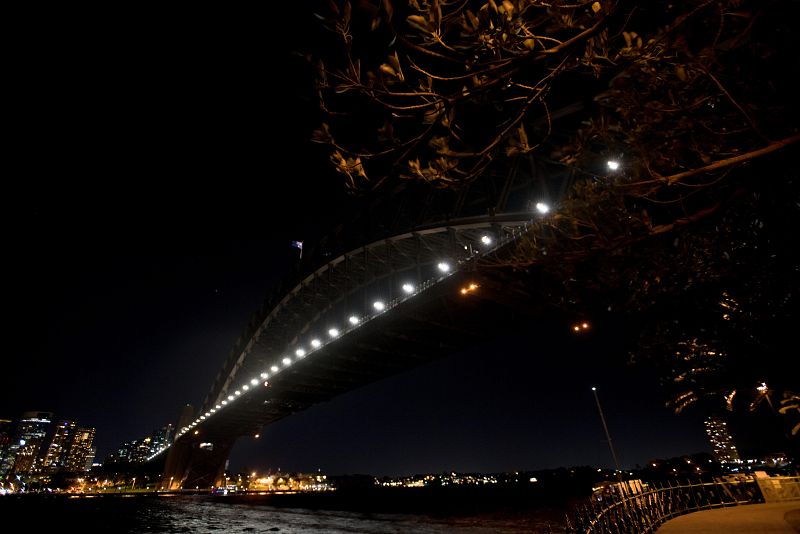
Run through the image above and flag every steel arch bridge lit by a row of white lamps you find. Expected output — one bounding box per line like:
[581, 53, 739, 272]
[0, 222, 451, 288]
[163, 216, 545, 489]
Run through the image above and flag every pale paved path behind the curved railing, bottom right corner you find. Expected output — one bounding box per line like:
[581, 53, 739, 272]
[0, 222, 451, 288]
[656, 501, 800, 534]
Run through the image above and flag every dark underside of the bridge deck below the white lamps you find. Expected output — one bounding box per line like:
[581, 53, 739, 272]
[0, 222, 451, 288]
[182, 270, 544, 442]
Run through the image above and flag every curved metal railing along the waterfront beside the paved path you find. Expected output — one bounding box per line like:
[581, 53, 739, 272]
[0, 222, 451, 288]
[566, 477, 764, 534]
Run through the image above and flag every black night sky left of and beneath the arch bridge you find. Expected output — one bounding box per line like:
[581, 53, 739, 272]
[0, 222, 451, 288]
[0, 8, 784, 475]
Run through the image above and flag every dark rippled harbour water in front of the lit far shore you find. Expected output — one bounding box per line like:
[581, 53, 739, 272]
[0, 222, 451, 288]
[0, 495, 564, 534]
